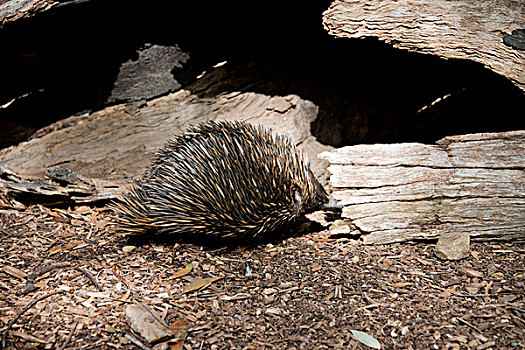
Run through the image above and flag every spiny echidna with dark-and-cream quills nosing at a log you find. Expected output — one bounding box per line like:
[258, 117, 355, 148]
[114, 121, 328, 239]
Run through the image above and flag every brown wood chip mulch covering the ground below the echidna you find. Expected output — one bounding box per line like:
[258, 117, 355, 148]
[0, 206, 525, 350]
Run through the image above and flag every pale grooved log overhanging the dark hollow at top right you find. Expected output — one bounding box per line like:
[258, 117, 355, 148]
[323, 0, 525, 91]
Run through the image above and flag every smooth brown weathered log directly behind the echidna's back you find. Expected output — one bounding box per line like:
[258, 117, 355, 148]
[0, 90, 332, 205]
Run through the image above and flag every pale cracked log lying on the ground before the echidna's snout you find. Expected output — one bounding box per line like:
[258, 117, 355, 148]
[320, 131, 525, 244]
